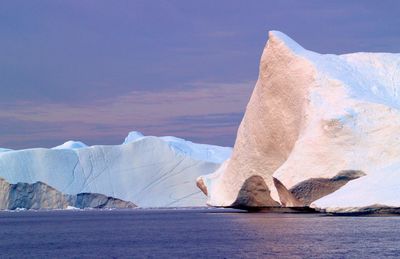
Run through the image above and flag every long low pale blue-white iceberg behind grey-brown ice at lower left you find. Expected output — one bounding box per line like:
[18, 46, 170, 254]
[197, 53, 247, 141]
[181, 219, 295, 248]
[0, 132, 231, 207]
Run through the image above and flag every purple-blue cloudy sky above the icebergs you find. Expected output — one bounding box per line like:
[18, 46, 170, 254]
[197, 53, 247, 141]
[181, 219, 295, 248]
[0, 0, 400, 149]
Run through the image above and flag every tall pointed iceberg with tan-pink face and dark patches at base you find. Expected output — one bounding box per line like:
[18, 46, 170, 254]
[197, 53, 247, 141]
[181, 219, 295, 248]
[197, 31, 400, 212]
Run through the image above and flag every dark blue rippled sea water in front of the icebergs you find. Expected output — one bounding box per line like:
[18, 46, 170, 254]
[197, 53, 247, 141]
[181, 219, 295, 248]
[0, 209, 400, 258]
